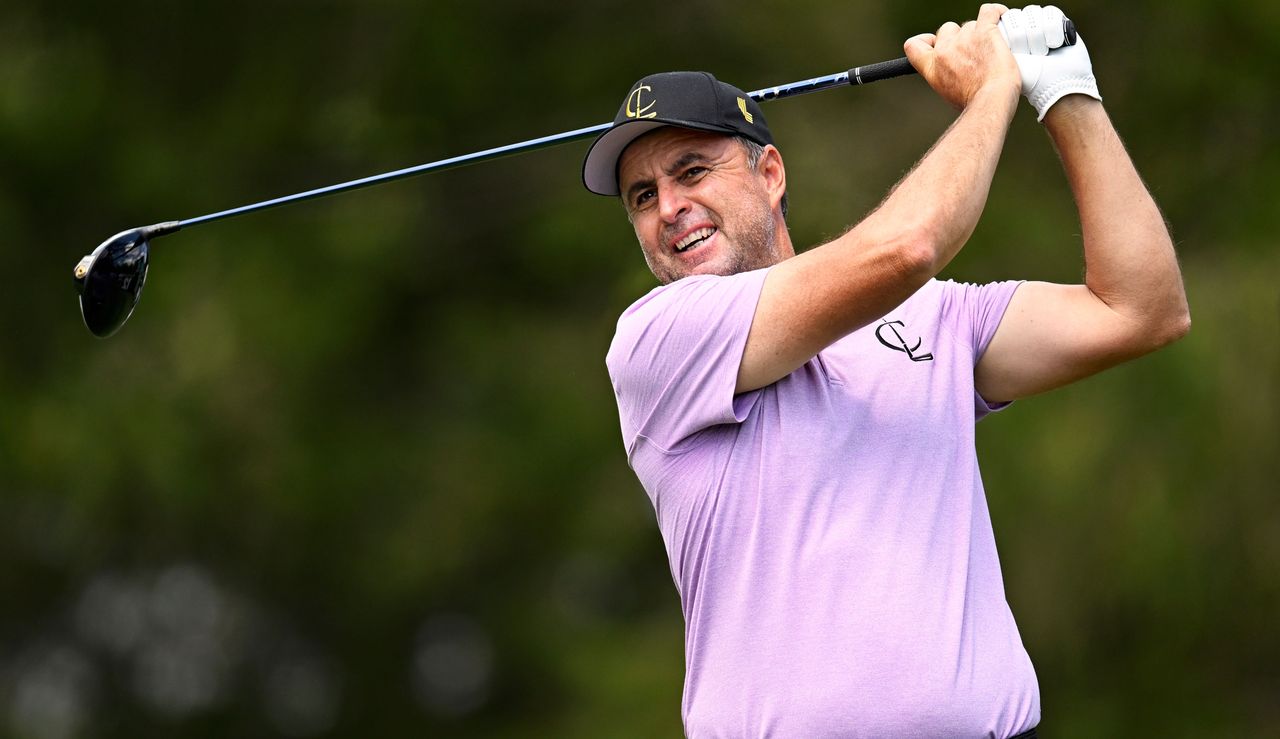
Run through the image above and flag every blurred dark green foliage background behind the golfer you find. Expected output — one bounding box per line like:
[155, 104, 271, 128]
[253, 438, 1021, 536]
[0, 0, 1280, 739]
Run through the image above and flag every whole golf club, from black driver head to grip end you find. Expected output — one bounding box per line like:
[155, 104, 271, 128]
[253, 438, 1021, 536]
[74, 19, 1075, 338]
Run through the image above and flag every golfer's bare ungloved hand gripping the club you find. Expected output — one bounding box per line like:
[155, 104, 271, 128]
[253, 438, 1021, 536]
[904, 3, 1021, 109]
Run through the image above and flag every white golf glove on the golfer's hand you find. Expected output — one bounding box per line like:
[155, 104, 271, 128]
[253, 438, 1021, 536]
[1000, 5, 1102, 120]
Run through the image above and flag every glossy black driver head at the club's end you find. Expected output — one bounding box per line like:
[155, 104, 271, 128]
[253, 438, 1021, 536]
[76, 228, 151, 338]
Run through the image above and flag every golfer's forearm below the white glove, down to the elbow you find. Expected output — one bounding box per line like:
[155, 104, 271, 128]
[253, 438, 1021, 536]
[1044, 95, 1189, 343]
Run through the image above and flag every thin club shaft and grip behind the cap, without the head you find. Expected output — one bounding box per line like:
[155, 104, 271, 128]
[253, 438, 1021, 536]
[180, 56, 915, 233]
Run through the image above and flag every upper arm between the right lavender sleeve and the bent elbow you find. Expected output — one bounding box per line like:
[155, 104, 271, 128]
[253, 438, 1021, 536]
[974, 282, 1142, 402]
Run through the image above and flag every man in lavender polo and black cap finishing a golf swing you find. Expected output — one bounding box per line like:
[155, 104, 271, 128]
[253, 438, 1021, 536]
[584, 5, 1189, 738]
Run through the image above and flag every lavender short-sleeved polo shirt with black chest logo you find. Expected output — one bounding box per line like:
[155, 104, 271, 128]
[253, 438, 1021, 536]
[607, 270, 1039, 738]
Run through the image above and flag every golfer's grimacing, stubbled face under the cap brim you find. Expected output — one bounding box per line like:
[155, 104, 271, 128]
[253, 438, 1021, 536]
[618, 128, 777, 283]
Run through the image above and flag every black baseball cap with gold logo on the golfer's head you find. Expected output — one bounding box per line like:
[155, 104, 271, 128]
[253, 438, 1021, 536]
[582, 72, 773, 195]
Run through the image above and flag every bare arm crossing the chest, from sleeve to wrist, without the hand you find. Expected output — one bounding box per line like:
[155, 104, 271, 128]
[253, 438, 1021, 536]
[737, 87, 1018, 392]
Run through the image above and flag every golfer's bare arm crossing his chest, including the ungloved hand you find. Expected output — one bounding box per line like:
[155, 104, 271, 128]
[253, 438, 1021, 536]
[737, 10, 1020, 392]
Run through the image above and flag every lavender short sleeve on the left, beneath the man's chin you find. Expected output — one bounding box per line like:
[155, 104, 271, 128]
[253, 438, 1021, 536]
[605, 269, 768, 457]
